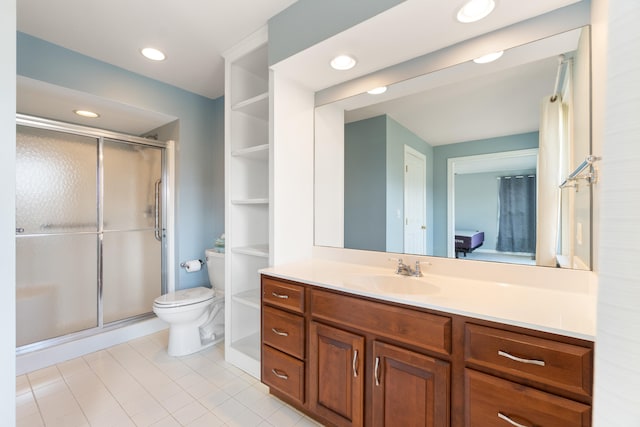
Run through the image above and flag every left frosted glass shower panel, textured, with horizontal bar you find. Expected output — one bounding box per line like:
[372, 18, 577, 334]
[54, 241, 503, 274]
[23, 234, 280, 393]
[16, 126, 98, 347]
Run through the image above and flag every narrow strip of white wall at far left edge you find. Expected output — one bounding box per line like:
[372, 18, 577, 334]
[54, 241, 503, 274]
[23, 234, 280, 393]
[0, 0, 16, 426]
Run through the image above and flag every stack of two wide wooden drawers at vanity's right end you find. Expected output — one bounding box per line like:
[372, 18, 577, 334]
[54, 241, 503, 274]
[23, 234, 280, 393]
[464, 322, 593, 427]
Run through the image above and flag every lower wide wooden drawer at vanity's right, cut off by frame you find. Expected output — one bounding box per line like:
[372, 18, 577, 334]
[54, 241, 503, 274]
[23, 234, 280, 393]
[465, 369, 591, 427]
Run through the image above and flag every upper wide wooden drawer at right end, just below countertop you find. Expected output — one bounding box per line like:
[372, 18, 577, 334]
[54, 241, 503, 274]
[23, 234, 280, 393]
[465, 324, 593, 396]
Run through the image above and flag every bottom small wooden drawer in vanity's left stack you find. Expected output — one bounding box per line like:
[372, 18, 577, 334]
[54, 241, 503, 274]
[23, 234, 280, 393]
[262, 345, 304, 403]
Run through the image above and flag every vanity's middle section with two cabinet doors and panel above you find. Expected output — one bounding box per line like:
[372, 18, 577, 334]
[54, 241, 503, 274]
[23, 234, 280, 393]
[309, 289, 451, 427]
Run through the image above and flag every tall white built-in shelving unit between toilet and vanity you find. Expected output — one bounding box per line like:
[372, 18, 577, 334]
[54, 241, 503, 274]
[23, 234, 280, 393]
[225, 26, 271, 378]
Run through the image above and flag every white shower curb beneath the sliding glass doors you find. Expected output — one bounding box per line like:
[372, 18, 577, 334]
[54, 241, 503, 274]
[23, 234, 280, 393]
[16, 317, 168, 375]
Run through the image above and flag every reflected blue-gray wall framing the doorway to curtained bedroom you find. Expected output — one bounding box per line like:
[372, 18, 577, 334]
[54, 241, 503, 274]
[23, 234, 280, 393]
[433, 132, 538, 256]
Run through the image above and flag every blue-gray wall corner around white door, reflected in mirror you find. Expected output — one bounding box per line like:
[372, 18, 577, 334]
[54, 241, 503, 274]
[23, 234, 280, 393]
[344, 115, 433, 253]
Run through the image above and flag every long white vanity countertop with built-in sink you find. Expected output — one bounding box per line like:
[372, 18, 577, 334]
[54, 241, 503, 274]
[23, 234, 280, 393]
[261, 259, 596, 341]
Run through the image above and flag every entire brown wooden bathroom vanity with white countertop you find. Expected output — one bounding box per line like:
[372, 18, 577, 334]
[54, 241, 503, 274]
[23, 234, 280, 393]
[262, 260, 595, 427]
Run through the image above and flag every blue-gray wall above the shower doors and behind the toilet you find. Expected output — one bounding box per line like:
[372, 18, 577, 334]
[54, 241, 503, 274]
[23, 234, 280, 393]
[17, 33, 224, 288]
